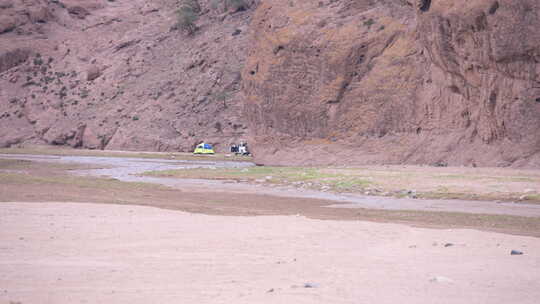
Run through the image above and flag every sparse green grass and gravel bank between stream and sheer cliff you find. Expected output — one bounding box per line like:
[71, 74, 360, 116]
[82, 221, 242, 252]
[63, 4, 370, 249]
[144, 167, 540, 203]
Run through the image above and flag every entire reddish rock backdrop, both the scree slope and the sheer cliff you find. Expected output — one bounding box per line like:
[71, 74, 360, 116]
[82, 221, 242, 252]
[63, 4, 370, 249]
[0, 0, 540, 168]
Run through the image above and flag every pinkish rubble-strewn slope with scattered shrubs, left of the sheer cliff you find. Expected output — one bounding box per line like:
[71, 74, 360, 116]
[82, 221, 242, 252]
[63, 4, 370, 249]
[0, 0, 252, 151]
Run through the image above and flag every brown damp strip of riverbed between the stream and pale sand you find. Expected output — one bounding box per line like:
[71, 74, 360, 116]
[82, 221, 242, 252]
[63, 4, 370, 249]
[0, 159, 540, 236]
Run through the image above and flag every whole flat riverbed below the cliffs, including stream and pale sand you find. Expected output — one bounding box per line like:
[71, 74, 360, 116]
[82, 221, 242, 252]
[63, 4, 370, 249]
[0, 153, 540, 304]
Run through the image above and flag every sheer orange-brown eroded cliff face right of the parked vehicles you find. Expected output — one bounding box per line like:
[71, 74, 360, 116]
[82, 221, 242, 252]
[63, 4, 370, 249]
[243, 0, 540, 167]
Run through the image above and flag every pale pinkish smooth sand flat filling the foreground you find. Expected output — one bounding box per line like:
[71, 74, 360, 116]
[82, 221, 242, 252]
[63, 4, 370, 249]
[0, 203, 540, 304]
